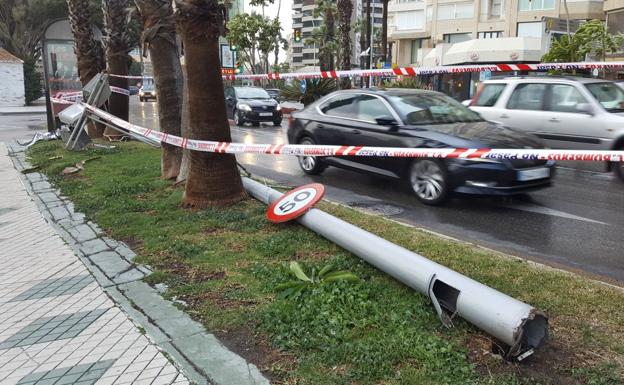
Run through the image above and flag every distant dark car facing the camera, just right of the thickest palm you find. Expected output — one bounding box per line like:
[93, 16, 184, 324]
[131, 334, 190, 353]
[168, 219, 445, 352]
[225, 87, 282, 126]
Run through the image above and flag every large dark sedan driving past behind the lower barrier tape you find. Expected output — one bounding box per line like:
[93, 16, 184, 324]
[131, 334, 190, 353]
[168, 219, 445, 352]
[288, 89, 554, 205]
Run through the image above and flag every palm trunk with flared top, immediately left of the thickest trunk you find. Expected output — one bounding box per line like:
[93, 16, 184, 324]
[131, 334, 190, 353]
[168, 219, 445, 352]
[134, 0, 183, 179]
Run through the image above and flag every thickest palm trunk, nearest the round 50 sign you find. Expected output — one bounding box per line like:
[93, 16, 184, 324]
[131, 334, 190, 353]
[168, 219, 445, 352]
[176, 0, 245, 209]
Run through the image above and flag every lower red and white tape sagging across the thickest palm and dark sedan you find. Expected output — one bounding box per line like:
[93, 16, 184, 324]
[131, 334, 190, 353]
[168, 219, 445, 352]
[83, 104, 624, 162]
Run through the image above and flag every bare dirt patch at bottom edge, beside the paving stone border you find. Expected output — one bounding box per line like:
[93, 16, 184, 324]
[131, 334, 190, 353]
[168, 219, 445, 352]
[214, 328, 297, 385]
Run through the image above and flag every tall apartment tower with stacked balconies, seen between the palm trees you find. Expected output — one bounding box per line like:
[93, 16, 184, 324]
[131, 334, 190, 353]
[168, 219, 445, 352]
[290, 0, 383, 71]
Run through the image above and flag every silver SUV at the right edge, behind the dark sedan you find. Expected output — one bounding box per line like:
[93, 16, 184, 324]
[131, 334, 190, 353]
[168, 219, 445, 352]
[470, 77, 624, 180]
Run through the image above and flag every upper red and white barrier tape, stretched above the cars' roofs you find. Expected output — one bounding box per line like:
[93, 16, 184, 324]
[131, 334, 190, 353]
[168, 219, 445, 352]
[109, 61, 624, 80]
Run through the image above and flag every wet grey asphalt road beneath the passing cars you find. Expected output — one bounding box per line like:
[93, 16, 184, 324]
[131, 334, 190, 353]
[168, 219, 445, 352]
[0, 98, 624, 286]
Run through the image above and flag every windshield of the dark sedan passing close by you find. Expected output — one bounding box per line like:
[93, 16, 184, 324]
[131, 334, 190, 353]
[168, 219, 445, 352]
[389, 93, 483, 125]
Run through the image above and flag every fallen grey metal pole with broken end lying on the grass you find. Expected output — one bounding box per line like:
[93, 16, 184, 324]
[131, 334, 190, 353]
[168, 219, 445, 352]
[243, 178, 548, 360]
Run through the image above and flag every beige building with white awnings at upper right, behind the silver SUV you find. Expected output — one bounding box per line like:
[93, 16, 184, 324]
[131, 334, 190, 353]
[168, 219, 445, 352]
[389, 0, 604, 66]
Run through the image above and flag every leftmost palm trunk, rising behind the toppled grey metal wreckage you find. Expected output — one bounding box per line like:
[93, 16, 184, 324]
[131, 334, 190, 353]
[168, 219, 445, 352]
[67, 0, 104, 138]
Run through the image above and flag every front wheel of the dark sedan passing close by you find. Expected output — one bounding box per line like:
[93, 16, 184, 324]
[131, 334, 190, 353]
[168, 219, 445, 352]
[408, 159, 449, 205]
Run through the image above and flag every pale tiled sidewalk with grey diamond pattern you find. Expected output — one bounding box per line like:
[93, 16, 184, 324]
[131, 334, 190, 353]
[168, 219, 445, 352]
[0, 143, 189, 385]
